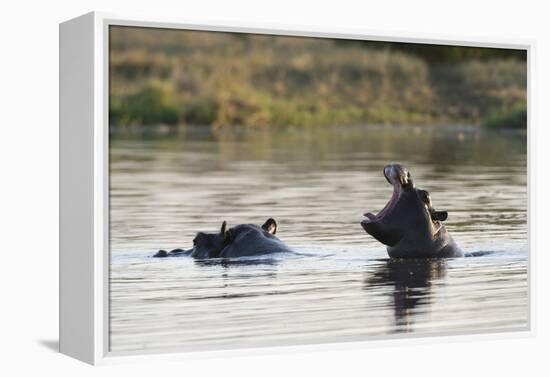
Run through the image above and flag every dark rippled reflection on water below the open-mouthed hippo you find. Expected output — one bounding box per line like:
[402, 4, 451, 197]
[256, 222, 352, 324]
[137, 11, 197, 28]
[363, 259, 447, 332]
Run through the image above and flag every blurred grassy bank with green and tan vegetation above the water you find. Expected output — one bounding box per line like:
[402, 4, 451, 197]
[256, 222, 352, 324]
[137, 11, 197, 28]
[110, 27, 527, 127]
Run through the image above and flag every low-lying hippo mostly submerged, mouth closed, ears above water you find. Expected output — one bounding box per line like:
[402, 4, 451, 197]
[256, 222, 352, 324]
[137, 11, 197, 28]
[153, 219, 291, 259]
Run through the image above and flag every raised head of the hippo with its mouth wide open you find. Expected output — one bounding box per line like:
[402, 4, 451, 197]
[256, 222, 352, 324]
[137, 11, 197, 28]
[361, 164, 447, 251]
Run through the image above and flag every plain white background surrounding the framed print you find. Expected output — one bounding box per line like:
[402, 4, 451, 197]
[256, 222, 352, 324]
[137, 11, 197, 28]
[0, 0, 550, 377]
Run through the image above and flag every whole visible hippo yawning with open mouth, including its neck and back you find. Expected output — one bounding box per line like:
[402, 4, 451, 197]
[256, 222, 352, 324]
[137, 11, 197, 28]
[361, 164, 463, 258]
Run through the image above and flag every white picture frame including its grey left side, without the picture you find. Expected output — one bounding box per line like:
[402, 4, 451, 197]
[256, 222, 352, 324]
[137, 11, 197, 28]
[59, 12, 536, 364]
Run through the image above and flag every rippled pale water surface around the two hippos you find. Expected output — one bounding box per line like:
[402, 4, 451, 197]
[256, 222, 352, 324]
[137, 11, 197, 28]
[110, 127, 528, 353]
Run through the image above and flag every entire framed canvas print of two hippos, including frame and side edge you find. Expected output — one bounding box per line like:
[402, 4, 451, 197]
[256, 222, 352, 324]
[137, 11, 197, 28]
[60, 13, 532, 364]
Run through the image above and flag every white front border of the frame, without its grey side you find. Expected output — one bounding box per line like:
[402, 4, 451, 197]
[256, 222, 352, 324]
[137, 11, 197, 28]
[64, 12, 536, 364]
